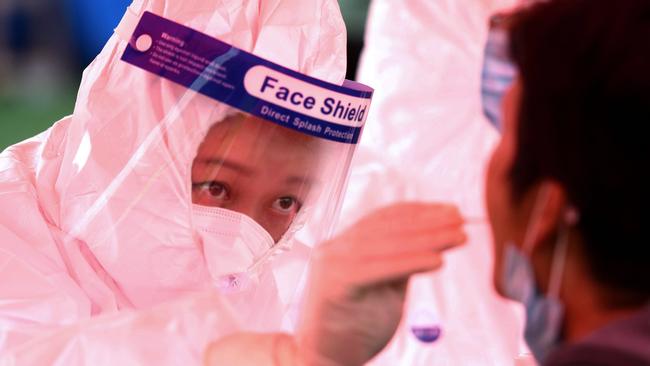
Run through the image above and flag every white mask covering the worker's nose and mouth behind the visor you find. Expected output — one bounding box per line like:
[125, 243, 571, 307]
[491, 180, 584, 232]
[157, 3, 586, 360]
[192, 205, 275, 291]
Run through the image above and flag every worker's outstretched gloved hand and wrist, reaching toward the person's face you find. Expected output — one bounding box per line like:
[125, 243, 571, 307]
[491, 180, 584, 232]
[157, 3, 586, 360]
[206, 203, 466, 366]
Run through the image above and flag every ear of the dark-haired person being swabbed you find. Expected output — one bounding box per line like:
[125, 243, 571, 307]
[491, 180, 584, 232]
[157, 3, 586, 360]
[527, 180, 568, 250]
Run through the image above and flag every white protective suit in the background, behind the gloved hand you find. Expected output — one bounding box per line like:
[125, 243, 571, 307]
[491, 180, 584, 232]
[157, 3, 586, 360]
[341, 0, 525, 365]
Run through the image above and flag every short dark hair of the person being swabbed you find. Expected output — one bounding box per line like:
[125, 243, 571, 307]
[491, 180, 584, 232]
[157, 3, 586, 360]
[510, 0, 650, 306]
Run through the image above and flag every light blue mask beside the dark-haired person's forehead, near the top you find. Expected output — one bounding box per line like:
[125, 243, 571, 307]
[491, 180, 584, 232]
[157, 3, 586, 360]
[481, 15, 517, 131]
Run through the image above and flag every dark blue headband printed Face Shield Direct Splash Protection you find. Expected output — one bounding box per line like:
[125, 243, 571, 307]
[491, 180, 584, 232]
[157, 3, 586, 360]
[116, 12, 373, 144]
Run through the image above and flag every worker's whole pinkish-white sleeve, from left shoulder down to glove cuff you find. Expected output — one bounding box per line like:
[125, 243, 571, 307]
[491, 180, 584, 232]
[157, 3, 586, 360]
[0, 119, 242, 365]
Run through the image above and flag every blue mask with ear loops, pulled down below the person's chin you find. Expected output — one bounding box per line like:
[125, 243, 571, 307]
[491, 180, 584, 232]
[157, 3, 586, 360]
[499, 192, 567, 362]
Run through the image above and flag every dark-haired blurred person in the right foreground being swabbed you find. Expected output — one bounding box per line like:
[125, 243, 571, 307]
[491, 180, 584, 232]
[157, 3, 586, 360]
[486, 0, 650, 365]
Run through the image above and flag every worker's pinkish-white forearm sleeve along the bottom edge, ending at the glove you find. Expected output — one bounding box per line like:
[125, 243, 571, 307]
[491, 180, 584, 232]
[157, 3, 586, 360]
[0, 293, 239, 366]
